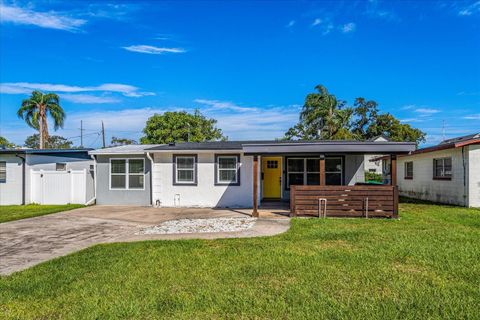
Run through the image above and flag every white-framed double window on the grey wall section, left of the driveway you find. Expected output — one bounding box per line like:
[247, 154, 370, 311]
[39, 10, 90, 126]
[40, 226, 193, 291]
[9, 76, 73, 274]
[110, 159, 145, 190]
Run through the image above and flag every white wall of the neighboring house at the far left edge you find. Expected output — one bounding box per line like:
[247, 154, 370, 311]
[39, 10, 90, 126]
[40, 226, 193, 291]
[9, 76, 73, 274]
[0, 154, 22, 205]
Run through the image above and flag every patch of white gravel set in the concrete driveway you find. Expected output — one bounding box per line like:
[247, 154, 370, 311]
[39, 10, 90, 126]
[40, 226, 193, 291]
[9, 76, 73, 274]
[136, 217, 257, 234]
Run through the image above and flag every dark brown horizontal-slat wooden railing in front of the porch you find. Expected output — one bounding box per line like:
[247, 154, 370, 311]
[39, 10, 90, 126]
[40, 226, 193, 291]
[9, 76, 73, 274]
[290, 185, 398, 218]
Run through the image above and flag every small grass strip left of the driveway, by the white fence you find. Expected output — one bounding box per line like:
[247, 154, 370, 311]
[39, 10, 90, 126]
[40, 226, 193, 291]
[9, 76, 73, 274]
[0, 204, 84, 223]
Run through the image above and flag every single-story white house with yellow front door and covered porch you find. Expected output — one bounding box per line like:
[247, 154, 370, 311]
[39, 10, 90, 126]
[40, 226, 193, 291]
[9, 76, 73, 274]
[89, 141, 415, 218]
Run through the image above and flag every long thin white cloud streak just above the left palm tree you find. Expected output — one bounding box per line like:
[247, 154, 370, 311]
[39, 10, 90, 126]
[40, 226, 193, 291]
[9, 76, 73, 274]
[0, 82, 155, 97]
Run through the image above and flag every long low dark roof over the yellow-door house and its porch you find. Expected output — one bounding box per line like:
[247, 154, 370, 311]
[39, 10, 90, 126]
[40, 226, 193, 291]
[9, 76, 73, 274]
[146, 140, 415, 154]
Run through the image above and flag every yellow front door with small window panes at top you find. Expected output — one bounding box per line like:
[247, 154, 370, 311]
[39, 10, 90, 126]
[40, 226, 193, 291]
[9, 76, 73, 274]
[262, 157, 282, 199]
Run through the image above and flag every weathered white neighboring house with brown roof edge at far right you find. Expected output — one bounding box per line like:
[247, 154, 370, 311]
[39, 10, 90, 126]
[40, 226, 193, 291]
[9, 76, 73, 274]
[397, 133, 480, 207]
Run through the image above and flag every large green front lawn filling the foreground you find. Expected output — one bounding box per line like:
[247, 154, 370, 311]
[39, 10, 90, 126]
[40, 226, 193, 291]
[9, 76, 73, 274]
[0, 203, 480, 319]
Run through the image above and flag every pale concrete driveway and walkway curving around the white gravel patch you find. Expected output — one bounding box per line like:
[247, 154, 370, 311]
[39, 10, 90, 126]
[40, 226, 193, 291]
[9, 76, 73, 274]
[0, 206, 290, 275]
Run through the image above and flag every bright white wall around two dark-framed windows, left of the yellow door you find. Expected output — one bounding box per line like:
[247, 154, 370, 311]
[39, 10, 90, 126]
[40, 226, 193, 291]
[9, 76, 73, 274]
[152, 151, 260, 208]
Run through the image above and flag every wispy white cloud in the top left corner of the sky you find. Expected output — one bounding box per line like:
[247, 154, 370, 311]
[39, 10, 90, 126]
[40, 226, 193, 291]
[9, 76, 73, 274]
[0, 3, 87, 32]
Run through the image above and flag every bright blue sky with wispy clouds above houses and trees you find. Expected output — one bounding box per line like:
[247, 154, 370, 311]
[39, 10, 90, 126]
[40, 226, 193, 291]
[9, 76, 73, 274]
[0, 0, 480, 147]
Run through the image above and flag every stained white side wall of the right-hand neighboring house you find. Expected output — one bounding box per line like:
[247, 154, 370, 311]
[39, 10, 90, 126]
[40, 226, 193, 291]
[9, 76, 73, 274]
[397, 148, 468, 206]
